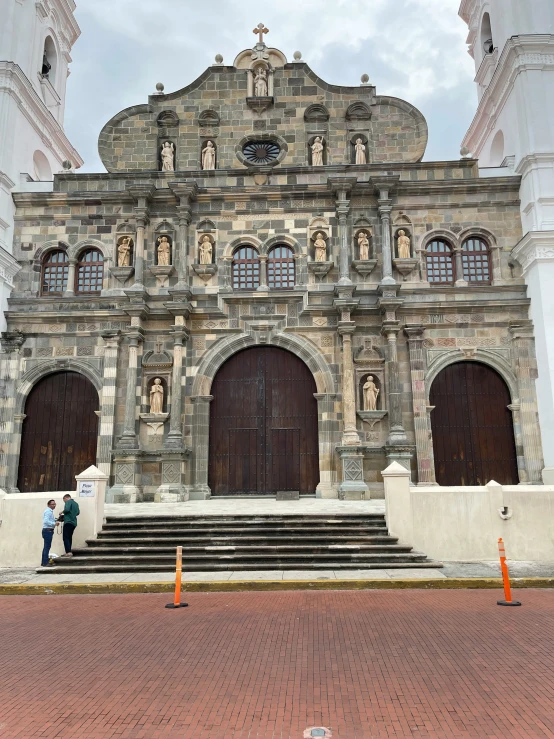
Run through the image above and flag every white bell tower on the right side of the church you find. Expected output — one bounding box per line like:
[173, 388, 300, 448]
[459, 0, 554, 484]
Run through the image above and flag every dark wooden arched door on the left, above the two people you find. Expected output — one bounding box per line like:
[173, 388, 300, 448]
[17, 372, 99, 493]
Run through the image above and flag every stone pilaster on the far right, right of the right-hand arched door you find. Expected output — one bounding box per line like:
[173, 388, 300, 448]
[510, 321, 544, 484]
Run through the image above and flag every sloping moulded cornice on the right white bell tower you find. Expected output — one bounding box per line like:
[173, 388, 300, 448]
[462, 34, 554, 156]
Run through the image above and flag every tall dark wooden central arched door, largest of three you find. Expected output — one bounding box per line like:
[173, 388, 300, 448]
[208, 346, 319, 495]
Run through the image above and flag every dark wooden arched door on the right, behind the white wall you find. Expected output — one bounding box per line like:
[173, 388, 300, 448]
[429, 362, 519, 485]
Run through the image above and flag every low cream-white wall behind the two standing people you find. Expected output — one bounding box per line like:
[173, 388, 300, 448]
[0, 466, 107, 567]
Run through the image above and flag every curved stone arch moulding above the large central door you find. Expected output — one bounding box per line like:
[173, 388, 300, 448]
[191, 333, 336, 396]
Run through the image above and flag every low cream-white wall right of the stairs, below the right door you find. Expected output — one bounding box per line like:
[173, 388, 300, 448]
[383, 463, 554, 562]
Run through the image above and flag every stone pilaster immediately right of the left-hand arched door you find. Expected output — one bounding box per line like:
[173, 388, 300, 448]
[96, 331, 121, 476]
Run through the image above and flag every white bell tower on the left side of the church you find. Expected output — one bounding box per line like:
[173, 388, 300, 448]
[0, 0, 83, 330]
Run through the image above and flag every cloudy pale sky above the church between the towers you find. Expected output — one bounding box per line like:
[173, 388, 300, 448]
[65, 0, 477, 172]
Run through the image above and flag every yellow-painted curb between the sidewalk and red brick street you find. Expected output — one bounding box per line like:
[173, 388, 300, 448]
[0, 577, 554, 595]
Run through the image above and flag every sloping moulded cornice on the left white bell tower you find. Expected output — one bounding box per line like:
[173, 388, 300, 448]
[0, 62, 83, 167]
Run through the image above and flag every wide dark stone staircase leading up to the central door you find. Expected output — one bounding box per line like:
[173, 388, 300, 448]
[49, 513, 442, 573]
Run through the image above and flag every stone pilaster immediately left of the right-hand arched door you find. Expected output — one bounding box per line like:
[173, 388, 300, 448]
[404, 326, 436, 485]
